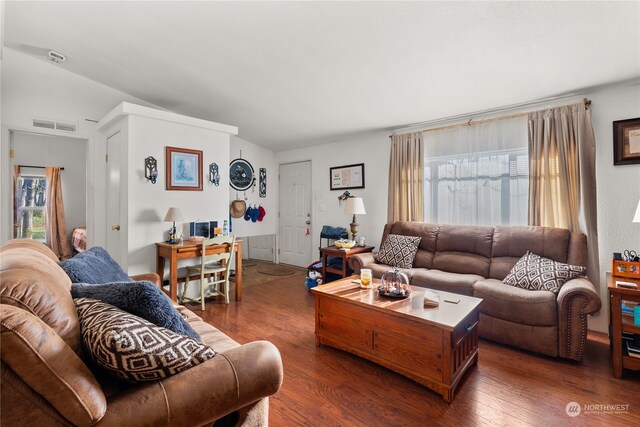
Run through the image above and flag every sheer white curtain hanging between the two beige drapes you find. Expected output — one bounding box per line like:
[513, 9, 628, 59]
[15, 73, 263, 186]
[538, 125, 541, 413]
[423, 116, 529, 225]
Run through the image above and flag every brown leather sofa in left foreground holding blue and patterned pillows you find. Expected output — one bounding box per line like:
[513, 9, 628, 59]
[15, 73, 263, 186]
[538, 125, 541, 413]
[0, 240, 283, 427]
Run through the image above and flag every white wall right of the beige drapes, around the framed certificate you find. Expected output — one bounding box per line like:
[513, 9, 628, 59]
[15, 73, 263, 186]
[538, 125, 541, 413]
[588, 83, 640, 332]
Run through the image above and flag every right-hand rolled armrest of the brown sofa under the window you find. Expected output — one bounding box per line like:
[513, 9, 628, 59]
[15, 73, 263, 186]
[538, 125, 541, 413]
[557, 277, 602, 360]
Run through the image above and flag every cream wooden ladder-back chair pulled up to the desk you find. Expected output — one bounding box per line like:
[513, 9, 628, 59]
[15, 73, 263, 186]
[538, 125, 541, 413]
[180, 235, 236, 311]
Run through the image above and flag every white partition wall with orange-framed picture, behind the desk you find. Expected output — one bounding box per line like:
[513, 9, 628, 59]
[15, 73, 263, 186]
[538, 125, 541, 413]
[94, 115, 229, 274]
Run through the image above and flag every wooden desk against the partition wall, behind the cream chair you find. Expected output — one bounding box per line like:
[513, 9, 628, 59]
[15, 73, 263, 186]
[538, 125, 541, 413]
[156, 240, 242, 301]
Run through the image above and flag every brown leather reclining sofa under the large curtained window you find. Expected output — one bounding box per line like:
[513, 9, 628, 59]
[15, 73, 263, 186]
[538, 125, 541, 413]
[349, 222, 601, 360]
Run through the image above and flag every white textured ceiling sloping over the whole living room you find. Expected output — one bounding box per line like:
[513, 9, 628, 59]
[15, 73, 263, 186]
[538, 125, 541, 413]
[5, 1, 640, 150]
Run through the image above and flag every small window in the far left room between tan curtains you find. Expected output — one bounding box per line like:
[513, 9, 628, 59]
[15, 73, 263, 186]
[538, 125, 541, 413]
[14, 175, 47, 242]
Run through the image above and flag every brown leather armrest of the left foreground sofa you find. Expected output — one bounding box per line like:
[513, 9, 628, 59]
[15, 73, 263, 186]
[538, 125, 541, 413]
[97, 341, 283, 426]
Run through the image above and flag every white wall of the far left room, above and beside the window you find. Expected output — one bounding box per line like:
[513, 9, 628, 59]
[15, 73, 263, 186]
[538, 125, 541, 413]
[13, 132, 87, 238]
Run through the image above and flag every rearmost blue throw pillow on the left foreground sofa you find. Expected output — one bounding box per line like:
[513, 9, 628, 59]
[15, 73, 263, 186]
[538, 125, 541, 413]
[60, 246, 131, 283]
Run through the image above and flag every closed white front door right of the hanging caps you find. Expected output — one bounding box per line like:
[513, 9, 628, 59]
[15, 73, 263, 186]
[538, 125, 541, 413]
[279, 161, 311, 267]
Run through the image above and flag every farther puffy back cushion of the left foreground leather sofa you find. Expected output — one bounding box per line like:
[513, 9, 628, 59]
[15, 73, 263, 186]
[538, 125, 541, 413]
[0, 243, 82, 355]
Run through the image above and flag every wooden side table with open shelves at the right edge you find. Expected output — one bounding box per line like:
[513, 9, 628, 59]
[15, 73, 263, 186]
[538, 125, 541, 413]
[607, 273, 640, 378]
